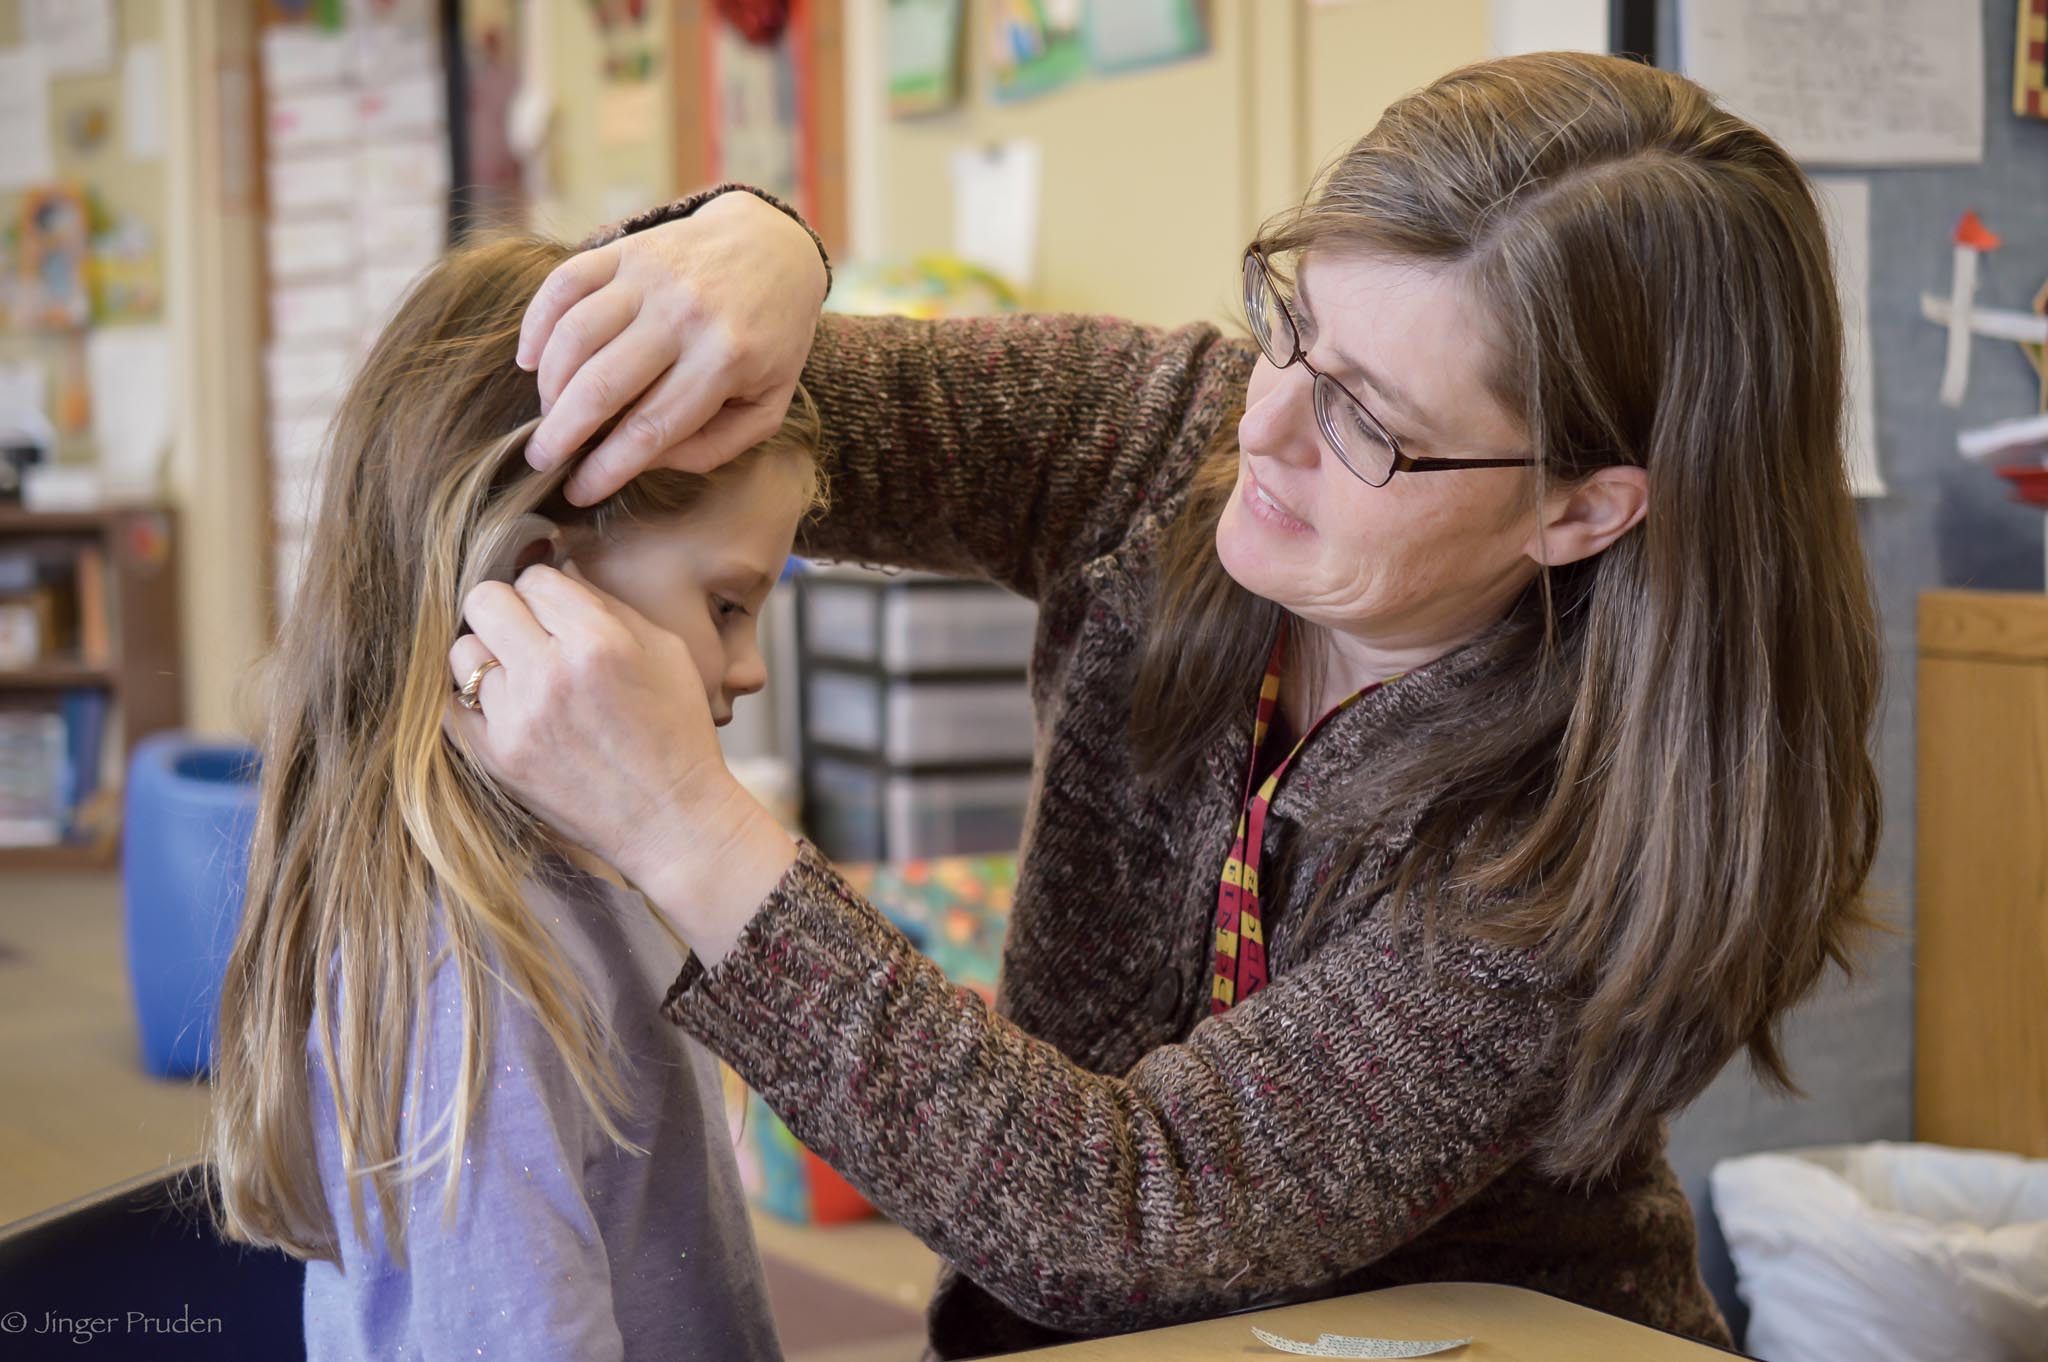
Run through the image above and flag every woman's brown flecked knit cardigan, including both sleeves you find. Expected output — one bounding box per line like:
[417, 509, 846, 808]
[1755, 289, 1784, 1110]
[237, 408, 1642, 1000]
[585, 193, 1729, 1358]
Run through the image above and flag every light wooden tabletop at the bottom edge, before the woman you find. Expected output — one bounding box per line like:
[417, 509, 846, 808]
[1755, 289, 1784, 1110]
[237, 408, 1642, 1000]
[1016, 1282, 1735, 1362]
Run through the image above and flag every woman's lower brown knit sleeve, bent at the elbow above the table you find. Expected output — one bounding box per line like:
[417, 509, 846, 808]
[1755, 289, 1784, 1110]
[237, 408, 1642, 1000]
[664, 846, 1561, 1333]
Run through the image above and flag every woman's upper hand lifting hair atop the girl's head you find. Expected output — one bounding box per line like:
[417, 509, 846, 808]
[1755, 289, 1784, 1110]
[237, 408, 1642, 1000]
[518, 193, 825, 506]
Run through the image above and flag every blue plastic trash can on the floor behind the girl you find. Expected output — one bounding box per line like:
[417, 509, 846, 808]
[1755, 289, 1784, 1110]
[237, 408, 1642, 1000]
[121, 733, 260, 1077]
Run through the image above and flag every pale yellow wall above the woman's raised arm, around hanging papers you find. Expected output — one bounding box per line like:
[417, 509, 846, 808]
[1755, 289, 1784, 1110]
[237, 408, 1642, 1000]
[850, 0, 1489, 324]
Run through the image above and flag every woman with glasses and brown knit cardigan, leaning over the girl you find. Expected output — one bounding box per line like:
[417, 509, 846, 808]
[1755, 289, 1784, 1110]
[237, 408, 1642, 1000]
[451, 53, 1880, 1358]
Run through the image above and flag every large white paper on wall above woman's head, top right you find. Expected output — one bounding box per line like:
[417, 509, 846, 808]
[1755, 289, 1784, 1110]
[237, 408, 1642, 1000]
[1679, 0, 1985, 166]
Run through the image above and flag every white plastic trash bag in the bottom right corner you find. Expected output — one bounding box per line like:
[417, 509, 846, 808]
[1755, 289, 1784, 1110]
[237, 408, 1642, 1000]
[1712, 1145, 2048, 1362]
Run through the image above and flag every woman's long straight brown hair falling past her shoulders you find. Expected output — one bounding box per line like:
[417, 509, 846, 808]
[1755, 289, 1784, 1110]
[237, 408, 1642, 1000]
[1135, 53, 1882, 1176]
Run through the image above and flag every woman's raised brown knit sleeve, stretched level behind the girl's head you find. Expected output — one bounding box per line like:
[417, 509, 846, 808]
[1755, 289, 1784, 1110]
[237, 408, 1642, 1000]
[799, 313, 1251, 598]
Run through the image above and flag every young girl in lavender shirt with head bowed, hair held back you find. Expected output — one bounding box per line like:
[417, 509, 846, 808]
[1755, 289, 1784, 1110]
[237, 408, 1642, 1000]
[209, 238, 819, 1362]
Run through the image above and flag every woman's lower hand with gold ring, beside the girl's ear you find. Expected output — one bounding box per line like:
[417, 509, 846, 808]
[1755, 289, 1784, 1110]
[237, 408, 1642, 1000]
[442, 563, 797, 969]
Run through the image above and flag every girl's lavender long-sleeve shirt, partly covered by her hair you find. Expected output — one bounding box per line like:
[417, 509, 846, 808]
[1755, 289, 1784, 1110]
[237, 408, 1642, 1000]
[305, 858, 782, 1362]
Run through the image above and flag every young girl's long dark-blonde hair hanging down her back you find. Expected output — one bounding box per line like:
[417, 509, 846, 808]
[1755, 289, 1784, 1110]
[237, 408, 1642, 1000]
[207, 236, 821, 1262]
